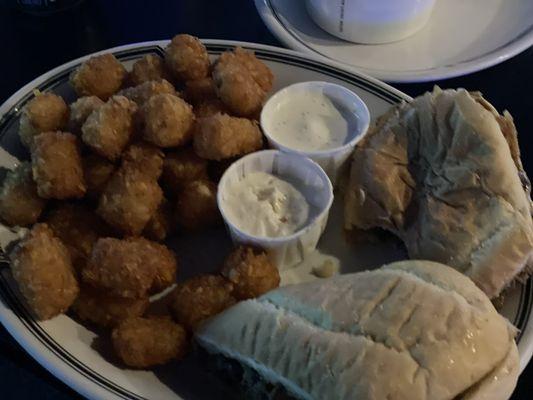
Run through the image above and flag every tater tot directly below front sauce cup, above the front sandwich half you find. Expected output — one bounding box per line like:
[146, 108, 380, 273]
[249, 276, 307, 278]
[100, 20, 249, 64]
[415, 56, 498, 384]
[221, 246, 280, 300]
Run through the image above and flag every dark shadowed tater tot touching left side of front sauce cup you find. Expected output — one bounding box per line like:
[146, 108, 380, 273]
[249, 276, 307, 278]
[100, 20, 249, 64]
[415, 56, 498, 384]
[176, 180, 221, 230]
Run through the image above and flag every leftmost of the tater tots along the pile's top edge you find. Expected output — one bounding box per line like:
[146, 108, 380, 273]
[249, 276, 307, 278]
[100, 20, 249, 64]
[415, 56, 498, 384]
[70, 53, 126, 100]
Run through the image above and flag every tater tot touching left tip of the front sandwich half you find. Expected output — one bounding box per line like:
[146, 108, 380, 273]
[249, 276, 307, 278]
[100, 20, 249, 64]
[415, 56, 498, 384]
[172, 275, 235, 331]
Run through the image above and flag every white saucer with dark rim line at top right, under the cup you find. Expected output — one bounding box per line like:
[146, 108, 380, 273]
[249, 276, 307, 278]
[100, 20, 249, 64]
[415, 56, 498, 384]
[254, 0, 533, 82]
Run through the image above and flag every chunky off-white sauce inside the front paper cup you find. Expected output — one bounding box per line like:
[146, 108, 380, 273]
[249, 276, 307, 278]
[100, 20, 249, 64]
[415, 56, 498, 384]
[224, 172, 310, 237]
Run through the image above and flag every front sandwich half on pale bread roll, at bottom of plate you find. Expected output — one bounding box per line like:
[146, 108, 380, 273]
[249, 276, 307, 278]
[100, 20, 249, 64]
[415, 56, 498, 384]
[196, 261, 519, 400]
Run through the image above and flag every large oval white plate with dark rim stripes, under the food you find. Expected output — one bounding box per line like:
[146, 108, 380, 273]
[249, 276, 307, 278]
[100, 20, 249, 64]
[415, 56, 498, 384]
[0, 40, 533, 400]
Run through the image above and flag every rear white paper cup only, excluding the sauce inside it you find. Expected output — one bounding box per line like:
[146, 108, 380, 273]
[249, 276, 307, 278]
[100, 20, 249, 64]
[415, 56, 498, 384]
[260, 81, 370, 188]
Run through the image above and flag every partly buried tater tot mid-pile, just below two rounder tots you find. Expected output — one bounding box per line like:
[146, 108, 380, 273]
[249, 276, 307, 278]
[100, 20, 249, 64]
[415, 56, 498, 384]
[122, 142, 164, 180]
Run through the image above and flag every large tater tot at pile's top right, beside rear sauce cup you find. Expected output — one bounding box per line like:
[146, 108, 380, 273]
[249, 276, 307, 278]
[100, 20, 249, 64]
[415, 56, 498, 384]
[213, 48, 273, 117]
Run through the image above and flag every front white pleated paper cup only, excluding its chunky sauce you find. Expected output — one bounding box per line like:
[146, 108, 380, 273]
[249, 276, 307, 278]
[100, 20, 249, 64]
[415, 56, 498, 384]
[217, 150, 333, 270]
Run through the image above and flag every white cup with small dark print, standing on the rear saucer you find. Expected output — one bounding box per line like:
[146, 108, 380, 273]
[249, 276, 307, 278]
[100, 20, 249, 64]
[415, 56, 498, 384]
[306, 0, 435, 44]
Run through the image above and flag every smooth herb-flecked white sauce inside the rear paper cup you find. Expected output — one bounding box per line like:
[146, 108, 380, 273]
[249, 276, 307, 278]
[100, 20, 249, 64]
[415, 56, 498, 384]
[268, 91, 356, 151]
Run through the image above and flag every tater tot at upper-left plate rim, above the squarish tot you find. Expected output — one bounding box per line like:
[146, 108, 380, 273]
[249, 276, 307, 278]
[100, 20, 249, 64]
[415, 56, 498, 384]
[19, 93, 69, 147]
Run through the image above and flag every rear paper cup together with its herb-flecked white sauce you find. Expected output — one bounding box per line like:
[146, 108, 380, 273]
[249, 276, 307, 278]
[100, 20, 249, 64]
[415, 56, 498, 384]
[260, 81, 370, 184]
